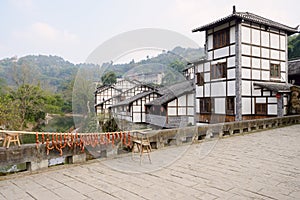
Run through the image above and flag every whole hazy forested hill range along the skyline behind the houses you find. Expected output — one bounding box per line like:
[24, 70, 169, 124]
[0, 47, 203, 92]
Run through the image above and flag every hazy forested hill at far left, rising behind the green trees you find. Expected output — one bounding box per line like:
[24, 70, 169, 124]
[0, 55, 78, 91]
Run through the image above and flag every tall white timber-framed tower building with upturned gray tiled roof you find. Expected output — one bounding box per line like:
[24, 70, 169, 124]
[192, 7, 298, 123]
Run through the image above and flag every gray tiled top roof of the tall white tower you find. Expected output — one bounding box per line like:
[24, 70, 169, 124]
[192, 12, 299, 35]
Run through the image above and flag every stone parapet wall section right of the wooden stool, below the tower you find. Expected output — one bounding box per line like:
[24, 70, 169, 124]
[149, 115, 300, 148]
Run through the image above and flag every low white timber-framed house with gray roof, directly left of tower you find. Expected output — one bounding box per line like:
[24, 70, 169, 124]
[145, 81, 195, 128]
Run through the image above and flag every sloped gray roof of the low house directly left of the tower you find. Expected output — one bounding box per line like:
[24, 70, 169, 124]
[145, 81, 194, 106]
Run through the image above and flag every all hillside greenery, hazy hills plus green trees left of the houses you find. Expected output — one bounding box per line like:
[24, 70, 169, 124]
[0, 47, 203, 131]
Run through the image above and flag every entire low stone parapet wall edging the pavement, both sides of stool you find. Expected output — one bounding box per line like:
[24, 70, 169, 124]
[0, 115, 300, 171]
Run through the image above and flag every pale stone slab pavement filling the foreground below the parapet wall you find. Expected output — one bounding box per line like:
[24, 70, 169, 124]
[0, 125, 300, 200]
